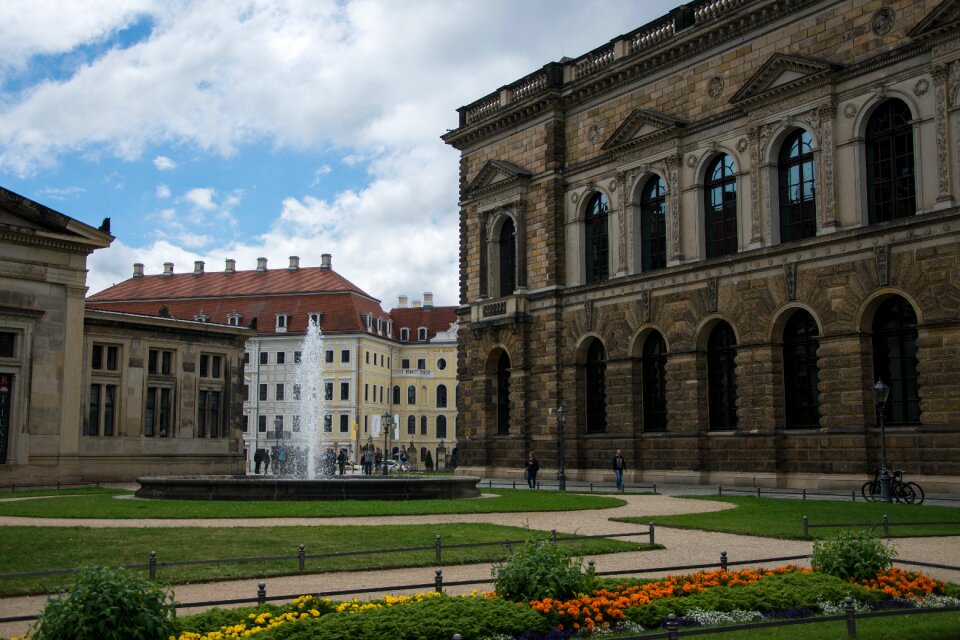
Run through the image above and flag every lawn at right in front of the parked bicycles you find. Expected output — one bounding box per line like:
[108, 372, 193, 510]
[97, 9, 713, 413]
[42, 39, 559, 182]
[618, 496, 960, 540]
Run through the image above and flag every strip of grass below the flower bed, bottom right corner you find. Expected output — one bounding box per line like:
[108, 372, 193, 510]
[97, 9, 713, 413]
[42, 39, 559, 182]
[613, 611, 960, 640]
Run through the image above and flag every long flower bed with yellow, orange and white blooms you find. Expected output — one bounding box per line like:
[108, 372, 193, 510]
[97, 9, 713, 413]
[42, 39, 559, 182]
[159, 565, 960, 640]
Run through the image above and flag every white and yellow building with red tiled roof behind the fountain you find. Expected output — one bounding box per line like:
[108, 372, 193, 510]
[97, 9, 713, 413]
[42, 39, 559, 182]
[88, 254, 457, 472]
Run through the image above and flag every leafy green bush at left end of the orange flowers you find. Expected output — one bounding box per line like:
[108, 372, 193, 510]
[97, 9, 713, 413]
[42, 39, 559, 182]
[493, 538, 596, 602]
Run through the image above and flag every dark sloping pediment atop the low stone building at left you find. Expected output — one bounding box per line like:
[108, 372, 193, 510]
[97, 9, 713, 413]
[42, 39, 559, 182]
[0, 187, 113, 248]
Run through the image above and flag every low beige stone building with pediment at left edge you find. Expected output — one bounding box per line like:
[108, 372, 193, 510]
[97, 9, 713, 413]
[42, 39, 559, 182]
[0, 188, 251, 485]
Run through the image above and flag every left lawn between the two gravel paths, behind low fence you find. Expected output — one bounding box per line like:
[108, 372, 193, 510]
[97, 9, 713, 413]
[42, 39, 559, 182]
[0, 523, 662, 596]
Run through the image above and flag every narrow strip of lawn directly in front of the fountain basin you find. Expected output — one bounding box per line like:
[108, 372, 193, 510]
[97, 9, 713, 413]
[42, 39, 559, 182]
[0, 489, 626, 519]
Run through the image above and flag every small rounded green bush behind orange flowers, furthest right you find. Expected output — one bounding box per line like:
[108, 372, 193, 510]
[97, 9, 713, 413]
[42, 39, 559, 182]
[810, 531, 896, 582]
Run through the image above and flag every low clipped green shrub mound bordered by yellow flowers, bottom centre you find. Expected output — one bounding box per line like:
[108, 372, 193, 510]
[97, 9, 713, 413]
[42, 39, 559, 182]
[257, 596, 550, 640]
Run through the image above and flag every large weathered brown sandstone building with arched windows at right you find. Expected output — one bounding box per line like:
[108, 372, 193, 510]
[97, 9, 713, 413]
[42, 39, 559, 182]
[443, 0, 960, 492]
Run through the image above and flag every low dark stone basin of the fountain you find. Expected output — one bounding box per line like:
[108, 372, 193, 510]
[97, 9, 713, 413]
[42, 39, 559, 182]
[136, 476, 480, 501]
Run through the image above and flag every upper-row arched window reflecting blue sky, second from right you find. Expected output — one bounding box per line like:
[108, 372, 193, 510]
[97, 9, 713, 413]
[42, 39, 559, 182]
[777, 129, 817, 242]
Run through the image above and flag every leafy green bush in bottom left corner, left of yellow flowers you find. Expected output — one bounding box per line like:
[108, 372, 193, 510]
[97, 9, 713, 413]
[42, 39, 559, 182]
[32, 568, 176, 640]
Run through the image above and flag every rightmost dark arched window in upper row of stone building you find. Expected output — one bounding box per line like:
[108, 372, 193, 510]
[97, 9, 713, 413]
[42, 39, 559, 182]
[865, 99, 917, 224]
